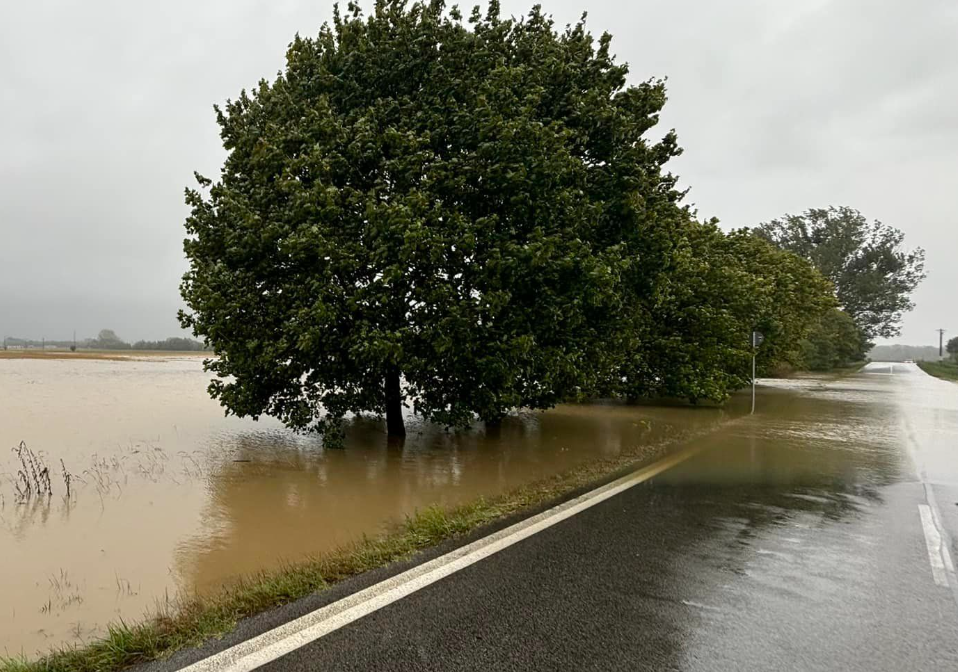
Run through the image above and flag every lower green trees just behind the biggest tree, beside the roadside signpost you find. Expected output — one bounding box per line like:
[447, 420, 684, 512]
[623, 221, 836, 402]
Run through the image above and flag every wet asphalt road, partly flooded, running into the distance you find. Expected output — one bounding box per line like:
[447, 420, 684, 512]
[153, 364, 958, 672]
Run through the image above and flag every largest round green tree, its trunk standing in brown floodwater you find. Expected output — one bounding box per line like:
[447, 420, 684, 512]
[180, 0, 685, 434]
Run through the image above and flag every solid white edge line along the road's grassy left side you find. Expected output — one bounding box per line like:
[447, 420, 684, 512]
[181, 449, 699, 672]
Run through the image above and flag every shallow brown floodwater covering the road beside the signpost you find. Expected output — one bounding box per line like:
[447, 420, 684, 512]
[658, 373, 914, 494]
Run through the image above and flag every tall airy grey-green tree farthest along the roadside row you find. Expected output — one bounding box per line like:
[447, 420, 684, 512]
[756, 207, 925, 341]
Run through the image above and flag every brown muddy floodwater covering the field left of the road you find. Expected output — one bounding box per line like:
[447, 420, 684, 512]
[0, 356, 745, 656]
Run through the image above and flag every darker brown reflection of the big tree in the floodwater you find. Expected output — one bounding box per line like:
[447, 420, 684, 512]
[176, 402, 744, 591]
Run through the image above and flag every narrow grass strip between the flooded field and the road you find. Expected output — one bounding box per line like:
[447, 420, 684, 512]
[0, 437, 687, 672]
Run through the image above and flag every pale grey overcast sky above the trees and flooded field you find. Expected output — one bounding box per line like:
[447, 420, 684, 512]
[0, 0, 958, 344]
